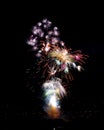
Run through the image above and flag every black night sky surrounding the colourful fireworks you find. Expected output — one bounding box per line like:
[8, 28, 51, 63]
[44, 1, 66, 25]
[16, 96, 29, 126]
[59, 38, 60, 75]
[0, 2, 104, 129]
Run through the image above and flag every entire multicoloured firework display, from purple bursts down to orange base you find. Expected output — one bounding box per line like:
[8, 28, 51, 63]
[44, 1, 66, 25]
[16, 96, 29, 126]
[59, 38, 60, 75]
[27, 19, 87, 118]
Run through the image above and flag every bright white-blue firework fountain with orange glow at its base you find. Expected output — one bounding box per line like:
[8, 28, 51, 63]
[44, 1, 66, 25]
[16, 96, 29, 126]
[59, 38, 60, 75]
[42, 78, 66, 118]
